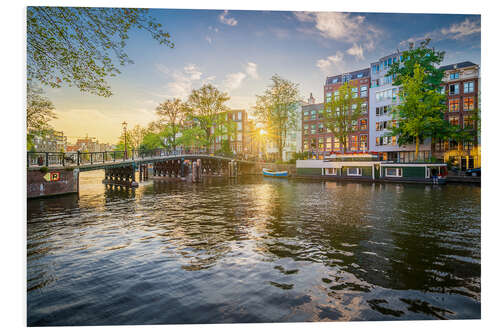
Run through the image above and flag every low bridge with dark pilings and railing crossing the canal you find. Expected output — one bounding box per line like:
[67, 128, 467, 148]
[27, 149, 256, 198]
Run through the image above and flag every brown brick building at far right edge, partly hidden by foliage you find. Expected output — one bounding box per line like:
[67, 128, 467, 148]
[435, 61, 481, 170]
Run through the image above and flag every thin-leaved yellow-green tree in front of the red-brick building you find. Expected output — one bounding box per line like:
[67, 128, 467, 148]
[323, 82, 363, 152]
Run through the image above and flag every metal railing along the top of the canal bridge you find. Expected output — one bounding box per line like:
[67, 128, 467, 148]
[27, 147, 244, 167]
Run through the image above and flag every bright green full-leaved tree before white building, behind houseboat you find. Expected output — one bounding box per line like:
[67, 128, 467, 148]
[390, 64, 445, 159]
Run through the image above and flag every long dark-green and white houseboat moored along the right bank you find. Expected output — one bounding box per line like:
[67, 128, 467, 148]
[296, 154, 448, 184]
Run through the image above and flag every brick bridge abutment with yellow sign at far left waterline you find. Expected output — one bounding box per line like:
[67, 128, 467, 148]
[27, 168, 80, 199]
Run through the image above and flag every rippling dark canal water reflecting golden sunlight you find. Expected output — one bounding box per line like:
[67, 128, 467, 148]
[27, 171, 481, 326]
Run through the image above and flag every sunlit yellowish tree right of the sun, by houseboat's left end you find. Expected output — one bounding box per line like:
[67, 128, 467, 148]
[254, 74, 300, 160]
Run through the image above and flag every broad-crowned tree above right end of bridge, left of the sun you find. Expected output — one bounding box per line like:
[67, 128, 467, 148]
[186, 84, 229, 148]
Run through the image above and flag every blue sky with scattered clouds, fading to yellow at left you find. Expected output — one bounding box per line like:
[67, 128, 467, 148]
[44, 9, 481, 143]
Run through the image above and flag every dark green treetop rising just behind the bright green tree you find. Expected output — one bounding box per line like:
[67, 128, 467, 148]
[386, 38, 445, 91]
